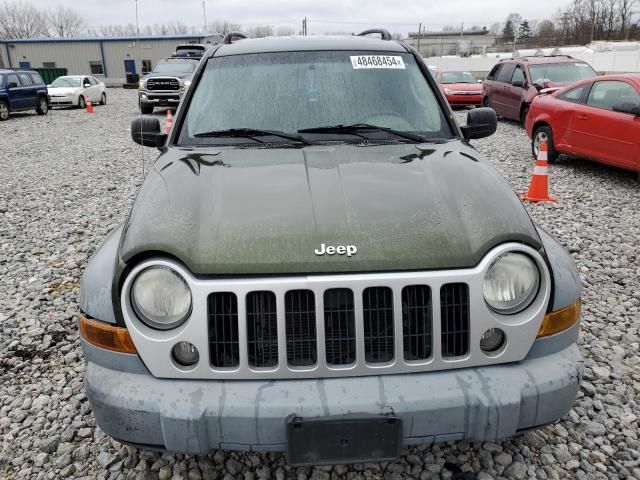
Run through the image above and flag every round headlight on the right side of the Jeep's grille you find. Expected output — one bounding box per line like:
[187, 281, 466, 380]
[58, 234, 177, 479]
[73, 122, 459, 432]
[482, 252, 540, 314]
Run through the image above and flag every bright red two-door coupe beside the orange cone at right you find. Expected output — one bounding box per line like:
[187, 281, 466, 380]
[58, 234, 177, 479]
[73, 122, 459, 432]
[525, 73, 640, 172]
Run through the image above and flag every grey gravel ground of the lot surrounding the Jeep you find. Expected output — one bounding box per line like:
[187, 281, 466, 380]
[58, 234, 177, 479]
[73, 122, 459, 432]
[0, 90, 640, 480]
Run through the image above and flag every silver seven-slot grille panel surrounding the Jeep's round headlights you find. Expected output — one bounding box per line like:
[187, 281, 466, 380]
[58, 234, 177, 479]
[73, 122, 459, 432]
[121, 243, 551, 380]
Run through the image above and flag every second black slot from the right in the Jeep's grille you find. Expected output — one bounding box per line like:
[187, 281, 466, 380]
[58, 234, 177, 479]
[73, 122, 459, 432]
[402, 285, 433, 361]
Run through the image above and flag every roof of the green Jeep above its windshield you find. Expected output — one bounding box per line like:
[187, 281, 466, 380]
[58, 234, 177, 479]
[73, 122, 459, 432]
[213, 35, 408, 57]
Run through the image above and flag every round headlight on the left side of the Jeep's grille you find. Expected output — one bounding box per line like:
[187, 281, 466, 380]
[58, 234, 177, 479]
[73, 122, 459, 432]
[131, 267, 191, 330]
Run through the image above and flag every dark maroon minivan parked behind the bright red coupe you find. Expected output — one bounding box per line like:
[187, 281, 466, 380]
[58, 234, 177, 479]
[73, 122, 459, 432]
[482, 55, 598, 125]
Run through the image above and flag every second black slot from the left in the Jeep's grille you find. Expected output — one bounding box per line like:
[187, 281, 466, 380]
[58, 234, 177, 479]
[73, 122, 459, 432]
[247, 292, 278, 368]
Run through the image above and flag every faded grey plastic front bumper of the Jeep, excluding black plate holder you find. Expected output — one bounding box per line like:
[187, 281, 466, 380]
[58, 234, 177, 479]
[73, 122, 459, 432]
[82, 340, 583, 454]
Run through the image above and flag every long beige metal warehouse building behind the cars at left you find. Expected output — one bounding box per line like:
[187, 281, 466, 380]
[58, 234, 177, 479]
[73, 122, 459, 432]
[0, 33, 222, 85]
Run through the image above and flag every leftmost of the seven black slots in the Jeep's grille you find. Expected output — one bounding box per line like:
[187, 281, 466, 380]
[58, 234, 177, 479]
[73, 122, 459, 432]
[208, 293, 240, 368]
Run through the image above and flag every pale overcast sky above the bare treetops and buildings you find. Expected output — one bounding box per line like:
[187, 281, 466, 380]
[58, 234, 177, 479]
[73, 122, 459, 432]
[31, 0, 568, 34]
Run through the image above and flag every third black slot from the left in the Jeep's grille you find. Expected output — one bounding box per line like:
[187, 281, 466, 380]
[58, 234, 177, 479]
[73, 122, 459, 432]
[284, 290, 318, 367]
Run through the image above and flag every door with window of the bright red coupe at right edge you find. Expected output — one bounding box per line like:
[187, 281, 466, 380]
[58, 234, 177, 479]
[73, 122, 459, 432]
[571, 80, 640, 169]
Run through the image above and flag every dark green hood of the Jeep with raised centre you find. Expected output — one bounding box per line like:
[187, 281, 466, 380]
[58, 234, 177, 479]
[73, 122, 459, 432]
[120, 141, 542, 275]
